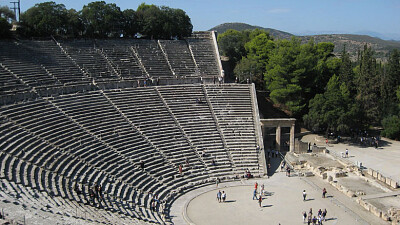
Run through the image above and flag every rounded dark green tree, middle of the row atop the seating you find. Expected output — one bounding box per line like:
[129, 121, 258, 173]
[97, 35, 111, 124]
[80, 1, 124, 37]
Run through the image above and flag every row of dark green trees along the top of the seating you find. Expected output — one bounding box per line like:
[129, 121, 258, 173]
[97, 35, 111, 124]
[18, 1, 193, 39]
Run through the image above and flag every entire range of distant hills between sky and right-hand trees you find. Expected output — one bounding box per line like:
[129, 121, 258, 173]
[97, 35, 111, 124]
[210, 23, 400, 60]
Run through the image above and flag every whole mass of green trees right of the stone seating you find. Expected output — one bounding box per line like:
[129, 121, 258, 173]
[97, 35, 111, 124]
[218, 30, 400, 139]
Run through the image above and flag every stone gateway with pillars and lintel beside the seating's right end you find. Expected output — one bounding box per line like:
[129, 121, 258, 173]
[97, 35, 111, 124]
[260, 118, 296, 152]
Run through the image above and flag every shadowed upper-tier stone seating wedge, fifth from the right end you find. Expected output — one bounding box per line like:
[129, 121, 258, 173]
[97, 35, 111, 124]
[60, 40, 119, 80]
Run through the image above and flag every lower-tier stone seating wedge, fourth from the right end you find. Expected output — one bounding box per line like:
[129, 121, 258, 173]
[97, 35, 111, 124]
[48, 92, 177, 205]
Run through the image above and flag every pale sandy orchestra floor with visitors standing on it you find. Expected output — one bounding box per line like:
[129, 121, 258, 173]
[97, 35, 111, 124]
[171, 172, 387, 225]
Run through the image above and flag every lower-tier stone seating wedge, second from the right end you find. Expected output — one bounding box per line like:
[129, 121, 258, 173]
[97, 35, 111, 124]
[157, 85, 233, 177]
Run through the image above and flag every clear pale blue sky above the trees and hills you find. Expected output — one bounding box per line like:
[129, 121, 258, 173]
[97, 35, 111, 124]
[0, 0, 400, 40]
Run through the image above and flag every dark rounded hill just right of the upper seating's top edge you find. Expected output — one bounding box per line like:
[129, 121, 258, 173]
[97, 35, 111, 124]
[209, 23, 293, 39]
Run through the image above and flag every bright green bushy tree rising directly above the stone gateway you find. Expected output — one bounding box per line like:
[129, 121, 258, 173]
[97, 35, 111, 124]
[265, 38, 338, 118]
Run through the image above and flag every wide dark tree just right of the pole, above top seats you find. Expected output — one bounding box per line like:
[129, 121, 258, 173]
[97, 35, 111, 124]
[21, 2, 69, 36]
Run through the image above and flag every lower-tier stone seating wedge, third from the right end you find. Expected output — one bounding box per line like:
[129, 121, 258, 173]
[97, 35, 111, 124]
[105, 88, 208, 181]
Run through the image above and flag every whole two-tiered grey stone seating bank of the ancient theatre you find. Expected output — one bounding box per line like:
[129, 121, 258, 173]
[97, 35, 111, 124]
[0, 32, 264, 224]
